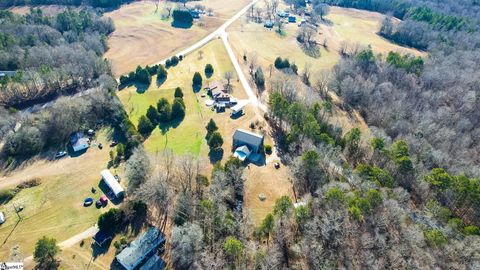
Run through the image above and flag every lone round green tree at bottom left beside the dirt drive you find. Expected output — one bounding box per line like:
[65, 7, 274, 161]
[33, 236, 60, 269]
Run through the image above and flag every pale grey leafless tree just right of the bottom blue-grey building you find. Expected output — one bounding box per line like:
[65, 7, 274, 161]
[171, 223, 203, 269]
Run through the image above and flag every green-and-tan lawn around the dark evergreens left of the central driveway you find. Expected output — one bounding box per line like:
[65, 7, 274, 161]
[118, 39, 248, 156]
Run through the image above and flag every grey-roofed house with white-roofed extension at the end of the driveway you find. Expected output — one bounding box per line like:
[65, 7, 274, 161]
[233, 129, 264, 161]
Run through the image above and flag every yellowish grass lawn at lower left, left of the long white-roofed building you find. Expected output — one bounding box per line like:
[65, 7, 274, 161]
[0, 130, 119, 261]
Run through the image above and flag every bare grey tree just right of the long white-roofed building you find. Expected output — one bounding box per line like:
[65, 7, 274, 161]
[125, 146, 152, 194]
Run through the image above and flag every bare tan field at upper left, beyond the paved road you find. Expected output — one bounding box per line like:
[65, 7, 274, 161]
[105, 0, 249, 77]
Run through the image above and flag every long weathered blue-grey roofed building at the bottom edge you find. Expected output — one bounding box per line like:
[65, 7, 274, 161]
[115, 227, 165, 270]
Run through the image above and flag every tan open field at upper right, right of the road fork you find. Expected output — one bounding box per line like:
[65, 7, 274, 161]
[227, 7, 425, 75]
